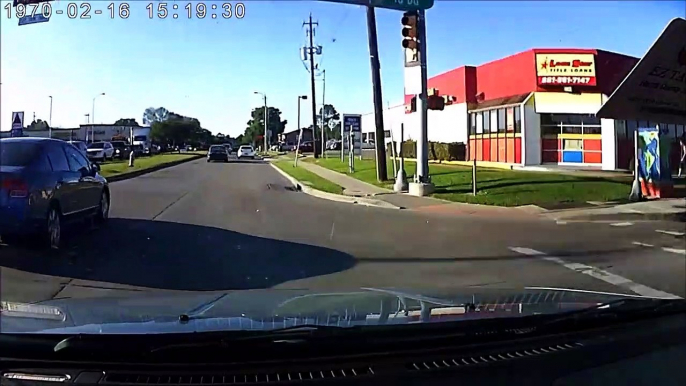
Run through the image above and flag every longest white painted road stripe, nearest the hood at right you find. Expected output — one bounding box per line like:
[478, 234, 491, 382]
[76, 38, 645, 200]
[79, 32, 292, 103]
[510, 247, 681, 299]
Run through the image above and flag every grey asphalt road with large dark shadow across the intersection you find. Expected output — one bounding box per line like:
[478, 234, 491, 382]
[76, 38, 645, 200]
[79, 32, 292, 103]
[0, 159, 686, 302]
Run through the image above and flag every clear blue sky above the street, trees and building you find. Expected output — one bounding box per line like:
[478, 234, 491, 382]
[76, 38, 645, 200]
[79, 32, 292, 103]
[0, 0, 686, 136]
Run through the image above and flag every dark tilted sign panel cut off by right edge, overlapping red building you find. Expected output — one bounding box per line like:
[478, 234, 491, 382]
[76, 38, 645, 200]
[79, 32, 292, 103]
[596, 18, 686, 124]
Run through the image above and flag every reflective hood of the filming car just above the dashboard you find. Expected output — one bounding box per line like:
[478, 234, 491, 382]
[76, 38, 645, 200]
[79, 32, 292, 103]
[0, 288, 656, 334]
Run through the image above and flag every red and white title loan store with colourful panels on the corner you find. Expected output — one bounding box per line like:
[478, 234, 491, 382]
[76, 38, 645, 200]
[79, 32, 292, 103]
[384, 49, 684, 170]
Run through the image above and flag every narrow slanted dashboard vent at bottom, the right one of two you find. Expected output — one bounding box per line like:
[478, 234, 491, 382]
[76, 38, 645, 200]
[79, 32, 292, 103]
[405, 343, 583, 371]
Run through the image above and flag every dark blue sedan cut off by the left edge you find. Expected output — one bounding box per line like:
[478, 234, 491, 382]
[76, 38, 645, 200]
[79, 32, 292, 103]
[0, 138, 110, 249]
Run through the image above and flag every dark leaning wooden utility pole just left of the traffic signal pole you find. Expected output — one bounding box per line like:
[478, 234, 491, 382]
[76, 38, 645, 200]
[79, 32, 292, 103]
[367, 5, 388, 182]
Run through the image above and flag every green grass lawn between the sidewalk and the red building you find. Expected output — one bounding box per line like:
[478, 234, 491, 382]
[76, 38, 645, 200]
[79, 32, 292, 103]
[306, 158, 631, 207]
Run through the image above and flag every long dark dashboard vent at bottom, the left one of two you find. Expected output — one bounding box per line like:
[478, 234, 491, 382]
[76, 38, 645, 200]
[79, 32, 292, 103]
[100, 367, 374, 385]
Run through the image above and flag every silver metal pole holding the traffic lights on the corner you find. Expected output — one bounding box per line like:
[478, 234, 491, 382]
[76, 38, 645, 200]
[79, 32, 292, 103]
[416, 10, 430, 183]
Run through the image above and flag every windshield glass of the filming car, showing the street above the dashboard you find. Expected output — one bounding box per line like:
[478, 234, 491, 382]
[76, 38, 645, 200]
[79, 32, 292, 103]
[0, 0, 686, 334]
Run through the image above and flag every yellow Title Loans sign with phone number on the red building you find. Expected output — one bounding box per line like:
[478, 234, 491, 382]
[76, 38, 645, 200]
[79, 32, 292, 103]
[536, 54, 596, 86]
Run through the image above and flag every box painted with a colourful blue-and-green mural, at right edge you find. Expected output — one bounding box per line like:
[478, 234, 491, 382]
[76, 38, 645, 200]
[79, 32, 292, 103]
[638, 127, 673, 198]
